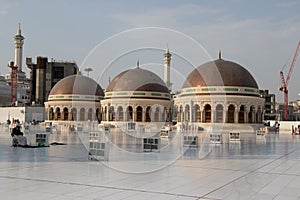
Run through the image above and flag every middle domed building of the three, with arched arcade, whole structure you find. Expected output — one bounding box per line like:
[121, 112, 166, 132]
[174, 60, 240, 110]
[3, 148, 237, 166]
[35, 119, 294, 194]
[101, 62, 172, 128]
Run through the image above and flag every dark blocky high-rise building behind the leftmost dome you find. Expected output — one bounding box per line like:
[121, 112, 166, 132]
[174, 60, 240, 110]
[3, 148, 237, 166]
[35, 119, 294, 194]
[26, 57, 78, 105]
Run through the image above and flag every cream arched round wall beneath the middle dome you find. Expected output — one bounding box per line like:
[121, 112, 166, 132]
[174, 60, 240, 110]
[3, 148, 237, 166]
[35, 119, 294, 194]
[101, 91, 173, 125]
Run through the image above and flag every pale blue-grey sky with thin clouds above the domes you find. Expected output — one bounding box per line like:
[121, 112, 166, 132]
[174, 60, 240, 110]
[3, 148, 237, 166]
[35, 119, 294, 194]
[0, 0, 300, 102]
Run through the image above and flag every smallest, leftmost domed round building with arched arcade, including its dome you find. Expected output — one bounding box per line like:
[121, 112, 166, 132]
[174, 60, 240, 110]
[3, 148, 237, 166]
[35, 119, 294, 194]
[45, 74, 104, 124]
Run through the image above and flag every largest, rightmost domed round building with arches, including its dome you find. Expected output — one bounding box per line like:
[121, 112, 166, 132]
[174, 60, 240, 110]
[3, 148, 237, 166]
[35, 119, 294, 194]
[175, 52, 264, 128]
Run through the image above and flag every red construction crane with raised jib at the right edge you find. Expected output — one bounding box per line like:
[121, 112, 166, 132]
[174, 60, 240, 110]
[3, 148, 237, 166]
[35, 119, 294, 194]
[279, 41, 300, 120]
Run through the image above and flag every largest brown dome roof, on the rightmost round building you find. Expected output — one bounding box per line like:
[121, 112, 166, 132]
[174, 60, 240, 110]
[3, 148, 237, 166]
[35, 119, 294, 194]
[182, 59, 258, 89]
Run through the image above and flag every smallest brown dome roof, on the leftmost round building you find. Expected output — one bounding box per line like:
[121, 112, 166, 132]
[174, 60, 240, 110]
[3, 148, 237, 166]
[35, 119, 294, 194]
[50, 74, 104, 97]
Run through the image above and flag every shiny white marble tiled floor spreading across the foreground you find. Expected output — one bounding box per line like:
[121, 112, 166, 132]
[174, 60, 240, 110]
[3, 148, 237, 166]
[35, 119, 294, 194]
[0, 128, 300, 200]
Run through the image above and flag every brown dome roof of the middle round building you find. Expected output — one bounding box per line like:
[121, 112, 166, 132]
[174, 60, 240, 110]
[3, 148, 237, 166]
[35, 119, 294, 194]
[106, 68, 169, 93]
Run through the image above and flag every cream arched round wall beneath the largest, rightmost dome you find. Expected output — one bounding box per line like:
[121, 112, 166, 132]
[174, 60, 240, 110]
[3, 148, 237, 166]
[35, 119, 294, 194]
[175, 86, 264, 124]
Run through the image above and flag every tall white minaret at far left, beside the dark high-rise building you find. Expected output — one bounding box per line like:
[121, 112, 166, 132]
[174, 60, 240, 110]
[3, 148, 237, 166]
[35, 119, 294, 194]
[14, 23, 25, 71]
